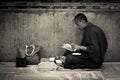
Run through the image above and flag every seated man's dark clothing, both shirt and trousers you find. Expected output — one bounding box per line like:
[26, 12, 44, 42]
[64, 23, 108, 68]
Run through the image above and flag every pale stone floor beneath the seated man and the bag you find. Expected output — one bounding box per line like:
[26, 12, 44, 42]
[0, 60, 120, 80]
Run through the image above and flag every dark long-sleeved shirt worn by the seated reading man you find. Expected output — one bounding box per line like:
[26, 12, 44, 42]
[81, 23, 108, 64]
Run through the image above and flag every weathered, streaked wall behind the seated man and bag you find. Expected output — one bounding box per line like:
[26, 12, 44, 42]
[0, 9, 120, 61]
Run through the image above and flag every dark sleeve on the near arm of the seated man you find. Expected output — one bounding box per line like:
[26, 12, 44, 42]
[86, 31, 101, 63]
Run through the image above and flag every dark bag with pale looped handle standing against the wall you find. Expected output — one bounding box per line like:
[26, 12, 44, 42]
[16, 45, 42, 67]
